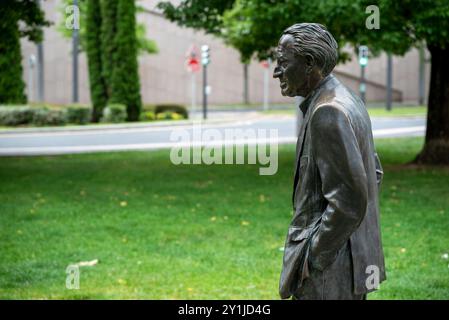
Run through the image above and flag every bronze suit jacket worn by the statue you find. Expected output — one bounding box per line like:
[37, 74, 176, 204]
[279, 74, 386, 299]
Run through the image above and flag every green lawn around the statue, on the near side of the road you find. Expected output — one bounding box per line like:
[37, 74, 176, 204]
[0, 138, 449, 299]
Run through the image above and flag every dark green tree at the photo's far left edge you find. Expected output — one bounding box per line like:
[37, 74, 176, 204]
[0, 0, 49, 104]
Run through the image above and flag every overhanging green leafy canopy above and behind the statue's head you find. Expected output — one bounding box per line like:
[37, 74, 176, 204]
[158, 0, 449, 60]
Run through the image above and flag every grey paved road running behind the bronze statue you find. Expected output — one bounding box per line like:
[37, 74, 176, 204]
[0, 112, 425, 156]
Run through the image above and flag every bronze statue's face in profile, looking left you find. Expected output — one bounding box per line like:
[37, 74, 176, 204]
[273, 34, 310, 97]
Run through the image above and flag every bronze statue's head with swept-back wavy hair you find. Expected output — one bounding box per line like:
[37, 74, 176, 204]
[273, 23, 338, 97]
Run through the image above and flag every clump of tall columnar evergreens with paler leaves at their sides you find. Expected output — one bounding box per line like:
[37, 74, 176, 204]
[59, 0, 154, 122]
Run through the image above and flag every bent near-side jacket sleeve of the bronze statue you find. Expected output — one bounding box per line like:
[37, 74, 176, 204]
[310, 105, 368, 270]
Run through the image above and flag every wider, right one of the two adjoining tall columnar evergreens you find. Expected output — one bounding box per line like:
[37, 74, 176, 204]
[110, 0, 142, 121]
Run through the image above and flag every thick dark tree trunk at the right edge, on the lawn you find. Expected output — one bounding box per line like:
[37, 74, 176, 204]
[415, 45, 449, 165]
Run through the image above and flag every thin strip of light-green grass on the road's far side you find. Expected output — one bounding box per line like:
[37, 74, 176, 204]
[263, 106, 427, 117]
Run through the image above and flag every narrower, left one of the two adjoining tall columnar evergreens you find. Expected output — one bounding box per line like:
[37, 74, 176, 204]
[85, 0, 108, 122]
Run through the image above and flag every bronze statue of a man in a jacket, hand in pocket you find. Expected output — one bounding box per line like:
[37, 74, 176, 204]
[273, 23, 386, 299]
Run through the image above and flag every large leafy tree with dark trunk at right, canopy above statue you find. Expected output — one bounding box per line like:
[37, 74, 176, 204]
[157, 0, 449, 164]
